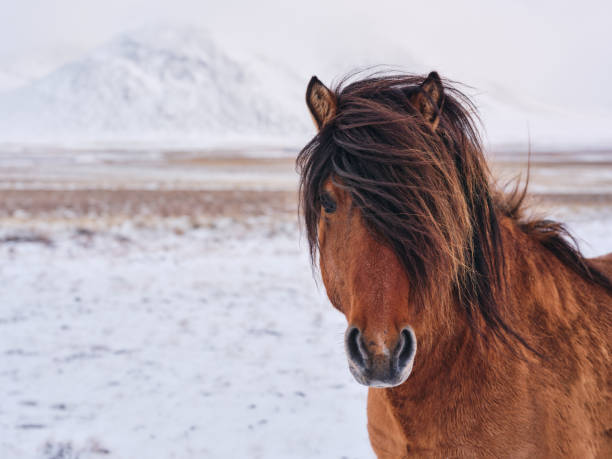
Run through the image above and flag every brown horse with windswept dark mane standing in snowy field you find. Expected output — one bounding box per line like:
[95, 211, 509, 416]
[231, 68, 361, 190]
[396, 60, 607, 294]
[298, 72, 612, 458]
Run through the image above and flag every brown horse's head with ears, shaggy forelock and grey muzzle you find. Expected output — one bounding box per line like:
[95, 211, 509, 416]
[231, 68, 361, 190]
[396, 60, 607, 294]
[298, 72, 499, 387]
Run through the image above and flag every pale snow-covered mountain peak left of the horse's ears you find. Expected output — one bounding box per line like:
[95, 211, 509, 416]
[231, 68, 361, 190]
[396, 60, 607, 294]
[0, 27, 310, 145]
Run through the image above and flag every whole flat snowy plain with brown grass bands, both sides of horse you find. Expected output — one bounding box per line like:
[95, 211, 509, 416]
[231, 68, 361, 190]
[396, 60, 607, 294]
[0, 149, 612, 459]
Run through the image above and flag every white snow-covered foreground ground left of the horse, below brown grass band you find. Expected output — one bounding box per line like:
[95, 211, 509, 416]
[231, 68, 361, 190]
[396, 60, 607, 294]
[0, 220, 372, 459]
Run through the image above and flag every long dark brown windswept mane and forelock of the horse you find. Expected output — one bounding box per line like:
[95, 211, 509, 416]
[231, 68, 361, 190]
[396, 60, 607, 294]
[297, 75, 612, 344]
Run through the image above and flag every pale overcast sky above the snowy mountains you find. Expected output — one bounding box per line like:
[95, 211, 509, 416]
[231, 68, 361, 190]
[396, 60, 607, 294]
[0, 0, 612, 109]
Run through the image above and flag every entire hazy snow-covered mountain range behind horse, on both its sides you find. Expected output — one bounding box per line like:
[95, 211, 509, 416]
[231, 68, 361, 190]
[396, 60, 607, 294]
[0, 26, 612, 150]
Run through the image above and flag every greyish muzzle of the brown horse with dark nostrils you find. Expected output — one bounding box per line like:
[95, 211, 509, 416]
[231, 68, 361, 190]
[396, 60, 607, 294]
[344, 326, 417, 387]
